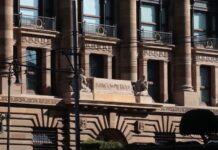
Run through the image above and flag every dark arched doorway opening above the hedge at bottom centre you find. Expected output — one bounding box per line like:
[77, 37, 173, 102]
[97, 129, 128, 146]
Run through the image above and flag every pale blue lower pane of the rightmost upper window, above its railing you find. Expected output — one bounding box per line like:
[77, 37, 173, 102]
[194, 13, 206, 30]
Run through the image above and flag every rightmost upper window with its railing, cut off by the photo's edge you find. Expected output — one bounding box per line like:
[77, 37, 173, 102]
[192, 1, 218, 48]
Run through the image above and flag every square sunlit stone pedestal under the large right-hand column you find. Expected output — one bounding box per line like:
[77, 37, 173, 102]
[174, 91, 199, 106]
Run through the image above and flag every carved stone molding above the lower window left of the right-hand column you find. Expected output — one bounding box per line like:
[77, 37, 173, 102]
[143, 50, 170, 61]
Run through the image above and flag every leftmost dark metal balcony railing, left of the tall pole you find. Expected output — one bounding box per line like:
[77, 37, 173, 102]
[14, 14, 56, 31]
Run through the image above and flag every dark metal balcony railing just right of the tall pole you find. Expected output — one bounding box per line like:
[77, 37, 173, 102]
[79, 22, 117, 37]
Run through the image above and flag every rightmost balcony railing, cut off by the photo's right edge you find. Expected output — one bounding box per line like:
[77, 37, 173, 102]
[193, 36, 218, 49]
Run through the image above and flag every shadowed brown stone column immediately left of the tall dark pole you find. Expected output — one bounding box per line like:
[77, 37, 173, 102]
[56, 0, 73, 96]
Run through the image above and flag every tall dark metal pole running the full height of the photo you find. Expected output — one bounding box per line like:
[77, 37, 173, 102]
[72, 0, 80, 150]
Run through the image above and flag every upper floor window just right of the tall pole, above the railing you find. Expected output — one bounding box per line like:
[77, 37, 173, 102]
[83, 0, 113, 25]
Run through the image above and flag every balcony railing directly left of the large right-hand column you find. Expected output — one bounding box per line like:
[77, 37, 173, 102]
[139, 30, 173, 44]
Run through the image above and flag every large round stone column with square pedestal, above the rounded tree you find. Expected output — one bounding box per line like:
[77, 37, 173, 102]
[174, 0, 197, 105]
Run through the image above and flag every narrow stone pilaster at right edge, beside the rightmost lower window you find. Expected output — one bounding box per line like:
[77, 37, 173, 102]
[211, 66, 218, 106]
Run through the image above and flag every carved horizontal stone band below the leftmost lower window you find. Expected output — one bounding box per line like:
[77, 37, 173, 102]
[0, 95, 61, 105]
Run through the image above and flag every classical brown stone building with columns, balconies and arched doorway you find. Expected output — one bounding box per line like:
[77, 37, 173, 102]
[0, 0, 218, 150]
